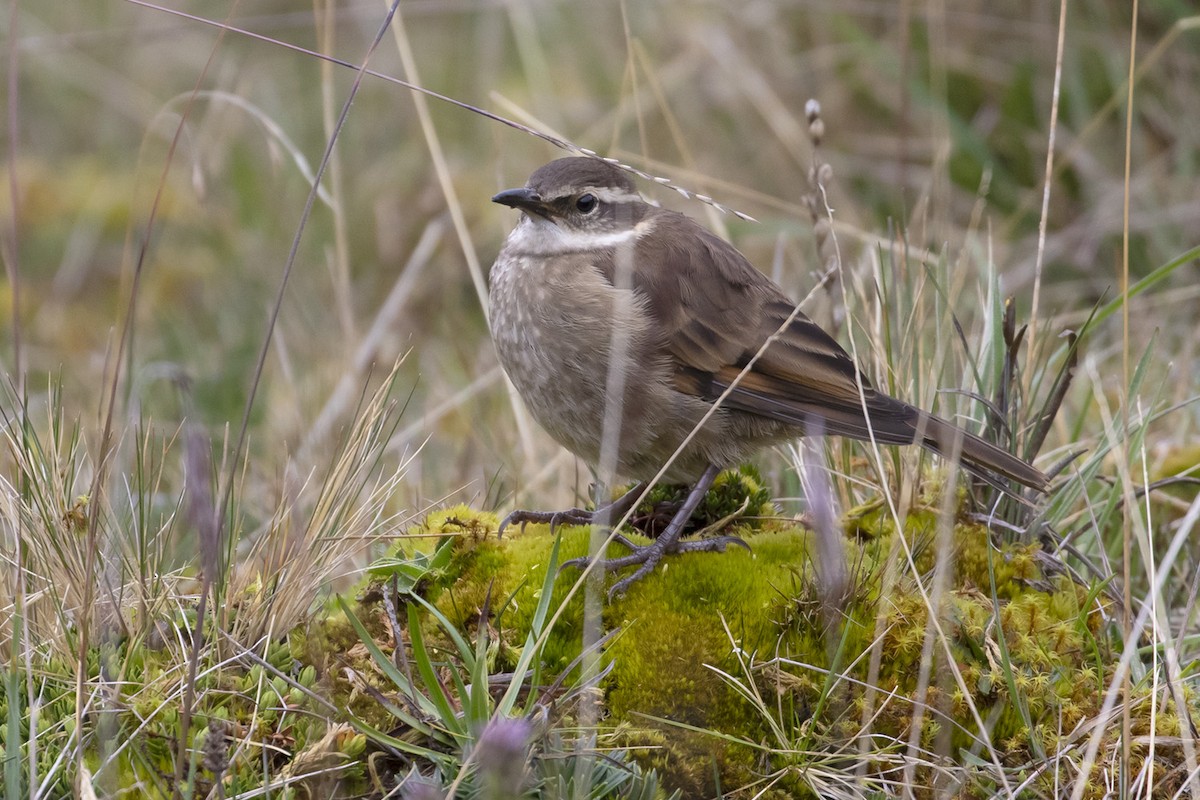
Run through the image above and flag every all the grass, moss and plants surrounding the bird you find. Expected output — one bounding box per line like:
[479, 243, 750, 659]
[0, 0, 1200, 800]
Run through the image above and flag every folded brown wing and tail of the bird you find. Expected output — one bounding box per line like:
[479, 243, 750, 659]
[608, 212, 1046, 491]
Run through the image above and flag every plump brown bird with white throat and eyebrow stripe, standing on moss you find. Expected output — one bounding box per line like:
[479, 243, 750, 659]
[490, 157, 1046, 594]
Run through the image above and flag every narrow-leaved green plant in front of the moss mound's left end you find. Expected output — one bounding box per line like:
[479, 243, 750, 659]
[338, 527, 678, 800]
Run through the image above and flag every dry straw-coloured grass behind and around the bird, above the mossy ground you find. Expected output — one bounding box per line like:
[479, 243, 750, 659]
[0, 0, 1200, 796]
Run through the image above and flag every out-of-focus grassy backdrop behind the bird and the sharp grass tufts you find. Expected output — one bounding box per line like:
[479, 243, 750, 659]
[0, 0, 1200, 532]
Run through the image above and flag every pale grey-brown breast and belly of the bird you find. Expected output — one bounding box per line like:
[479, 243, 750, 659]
[490, 259, 778, 482]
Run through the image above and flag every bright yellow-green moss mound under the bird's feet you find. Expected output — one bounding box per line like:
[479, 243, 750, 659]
[352, 491, 1190, 796]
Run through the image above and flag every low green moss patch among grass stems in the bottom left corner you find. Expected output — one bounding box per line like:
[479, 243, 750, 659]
[0, 631, 350, 798]
